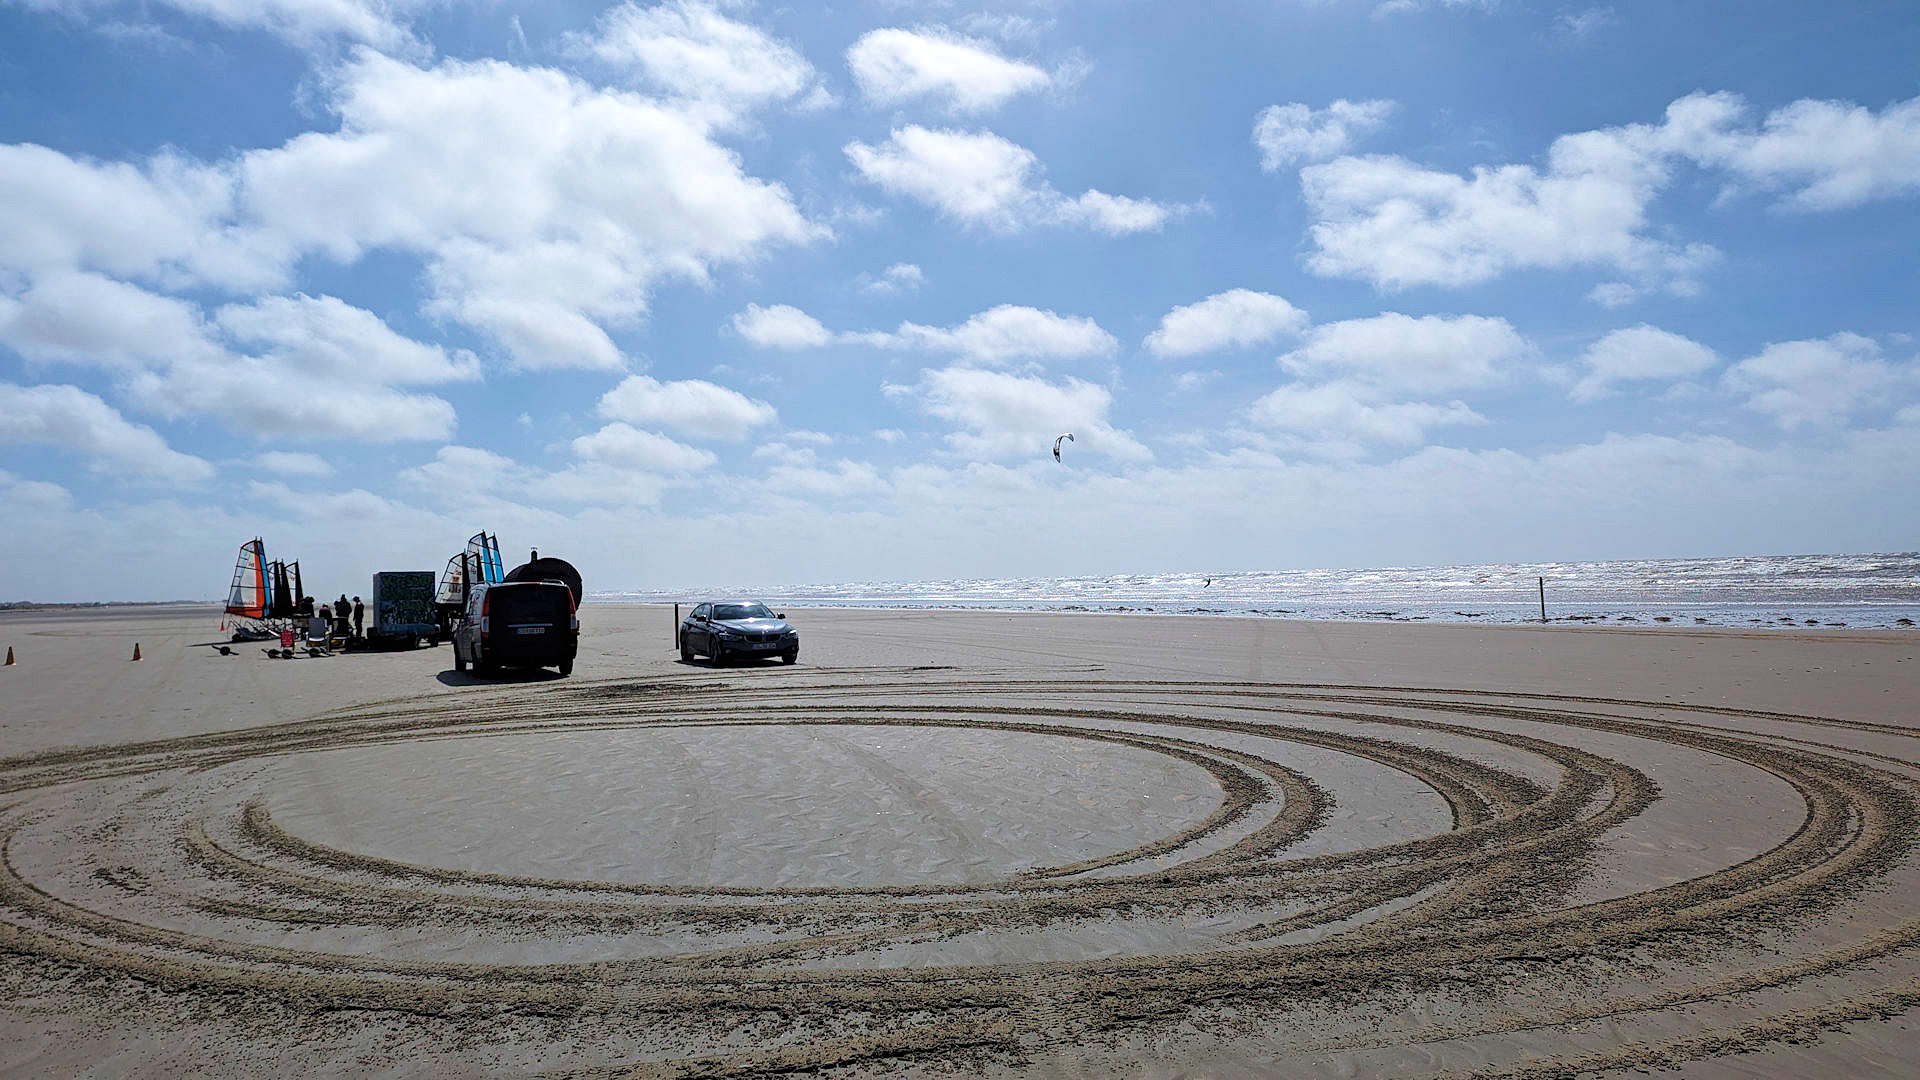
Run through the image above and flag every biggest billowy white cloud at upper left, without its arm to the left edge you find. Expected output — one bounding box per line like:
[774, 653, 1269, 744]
[240, 52, 822, 371]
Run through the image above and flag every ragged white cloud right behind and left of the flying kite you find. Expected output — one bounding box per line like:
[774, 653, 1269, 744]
[910, 367, 1152, 461]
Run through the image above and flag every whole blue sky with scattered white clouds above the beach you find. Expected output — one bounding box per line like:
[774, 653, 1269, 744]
[0, 0, 1920, 601]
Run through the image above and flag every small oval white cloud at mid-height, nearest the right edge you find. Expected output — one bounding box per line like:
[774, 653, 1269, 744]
[1726, 332, 1912, 429]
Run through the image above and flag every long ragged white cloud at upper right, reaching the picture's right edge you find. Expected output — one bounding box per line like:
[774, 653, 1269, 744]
[1300, 94, 1920, 292]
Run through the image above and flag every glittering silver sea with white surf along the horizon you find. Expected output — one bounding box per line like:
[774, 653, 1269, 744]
[588, 552, 1920, 630]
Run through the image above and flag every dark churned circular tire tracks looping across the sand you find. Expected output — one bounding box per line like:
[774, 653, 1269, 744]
[0, 673, 1920, 1074]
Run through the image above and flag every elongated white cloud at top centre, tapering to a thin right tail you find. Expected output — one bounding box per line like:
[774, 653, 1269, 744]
[845, 125, 1192, 234]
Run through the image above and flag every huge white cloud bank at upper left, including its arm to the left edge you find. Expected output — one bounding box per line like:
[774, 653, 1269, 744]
[0, 50, 826, 371]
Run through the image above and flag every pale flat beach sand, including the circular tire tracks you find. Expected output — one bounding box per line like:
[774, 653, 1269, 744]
[0, 605, 1920, 1076]
